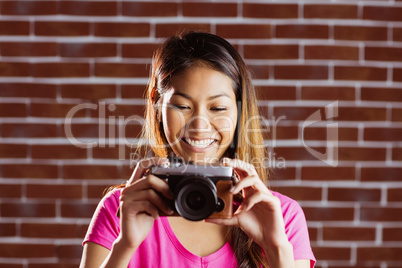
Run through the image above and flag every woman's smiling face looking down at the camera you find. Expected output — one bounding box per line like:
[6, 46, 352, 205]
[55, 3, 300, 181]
[162, 63, 237, 163]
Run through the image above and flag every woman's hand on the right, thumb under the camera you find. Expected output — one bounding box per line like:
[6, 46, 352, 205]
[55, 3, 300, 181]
[205, 159, 290, 260]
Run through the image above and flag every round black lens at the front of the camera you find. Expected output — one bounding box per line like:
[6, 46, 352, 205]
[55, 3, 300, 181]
[175, 177, 218, 221]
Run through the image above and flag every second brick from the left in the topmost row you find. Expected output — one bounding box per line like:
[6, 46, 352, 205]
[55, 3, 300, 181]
[60, 1, 117, 16]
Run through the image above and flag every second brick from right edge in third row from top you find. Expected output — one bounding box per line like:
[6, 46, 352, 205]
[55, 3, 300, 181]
[304, 45, 359, 61]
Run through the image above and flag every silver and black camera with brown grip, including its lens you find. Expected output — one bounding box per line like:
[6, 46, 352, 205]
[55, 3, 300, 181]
[150, 162, 235, 221]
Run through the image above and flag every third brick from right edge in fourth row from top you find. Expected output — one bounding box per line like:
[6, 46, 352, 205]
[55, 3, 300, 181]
[274, 65, 328, 80]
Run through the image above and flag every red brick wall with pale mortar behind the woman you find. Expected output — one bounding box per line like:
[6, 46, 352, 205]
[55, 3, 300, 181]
[0, 0, 402, 268]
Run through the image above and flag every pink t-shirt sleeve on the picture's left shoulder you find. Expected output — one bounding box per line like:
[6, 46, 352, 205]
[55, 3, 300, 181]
[83, 190, 120, 250]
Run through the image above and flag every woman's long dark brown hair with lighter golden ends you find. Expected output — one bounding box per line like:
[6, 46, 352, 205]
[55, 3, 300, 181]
[137, 32, 268, 268]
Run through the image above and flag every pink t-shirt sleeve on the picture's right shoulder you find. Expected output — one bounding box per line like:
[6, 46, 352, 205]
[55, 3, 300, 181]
[280, 193, 316, 268]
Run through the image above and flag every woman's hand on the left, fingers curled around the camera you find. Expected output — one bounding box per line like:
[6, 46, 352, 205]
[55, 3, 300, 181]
[116, 157, 174, 250]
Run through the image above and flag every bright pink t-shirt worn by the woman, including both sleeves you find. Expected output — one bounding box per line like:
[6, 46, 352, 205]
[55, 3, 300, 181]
[83, 190, 316, 268]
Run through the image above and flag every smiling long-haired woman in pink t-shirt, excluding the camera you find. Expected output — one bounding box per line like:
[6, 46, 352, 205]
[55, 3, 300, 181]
[81, 32, 315, 268]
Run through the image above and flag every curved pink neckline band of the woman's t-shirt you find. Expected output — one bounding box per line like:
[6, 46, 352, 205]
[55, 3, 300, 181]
[160, 217, 231, 264]
